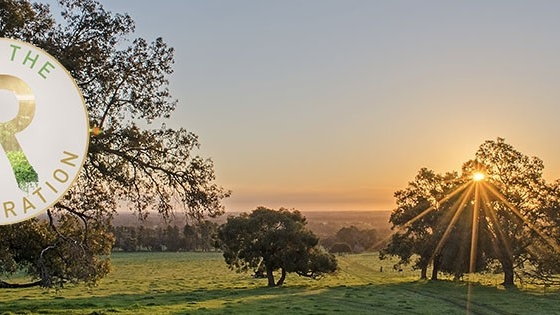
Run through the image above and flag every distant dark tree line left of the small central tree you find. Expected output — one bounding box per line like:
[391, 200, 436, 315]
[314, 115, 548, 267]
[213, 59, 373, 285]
[113, 220, 218, 252]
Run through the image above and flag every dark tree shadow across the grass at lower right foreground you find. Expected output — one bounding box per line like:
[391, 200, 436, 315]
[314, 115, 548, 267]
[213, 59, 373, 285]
[173, 281, 560, 315]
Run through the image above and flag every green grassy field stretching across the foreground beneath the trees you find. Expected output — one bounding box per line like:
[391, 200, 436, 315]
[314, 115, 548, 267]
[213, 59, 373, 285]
[0, 253, 560, 315]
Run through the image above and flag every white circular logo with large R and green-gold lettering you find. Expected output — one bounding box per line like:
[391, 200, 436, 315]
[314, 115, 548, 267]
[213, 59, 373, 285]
[0, 38, 89, 224]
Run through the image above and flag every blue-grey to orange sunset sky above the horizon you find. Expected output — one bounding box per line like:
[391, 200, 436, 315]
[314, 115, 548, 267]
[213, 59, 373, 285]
[47, 0, 560, 211]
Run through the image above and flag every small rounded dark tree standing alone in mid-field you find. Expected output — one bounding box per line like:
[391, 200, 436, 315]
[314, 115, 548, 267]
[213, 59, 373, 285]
[218, 207, 337, 287]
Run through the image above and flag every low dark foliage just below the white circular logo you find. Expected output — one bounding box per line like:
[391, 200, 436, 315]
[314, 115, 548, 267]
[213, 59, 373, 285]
[0, 215, 113, 288]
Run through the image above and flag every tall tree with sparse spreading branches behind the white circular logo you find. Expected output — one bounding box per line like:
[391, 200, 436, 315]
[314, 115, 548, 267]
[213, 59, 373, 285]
[0, 0, 229, 286]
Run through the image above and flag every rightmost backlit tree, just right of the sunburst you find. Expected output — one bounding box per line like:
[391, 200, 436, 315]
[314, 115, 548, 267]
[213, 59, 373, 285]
[472, 138, 560, 286]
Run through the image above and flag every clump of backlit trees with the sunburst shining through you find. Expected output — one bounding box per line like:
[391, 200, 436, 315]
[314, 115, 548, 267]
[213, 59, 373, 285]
[382, 138, 560, 286]
